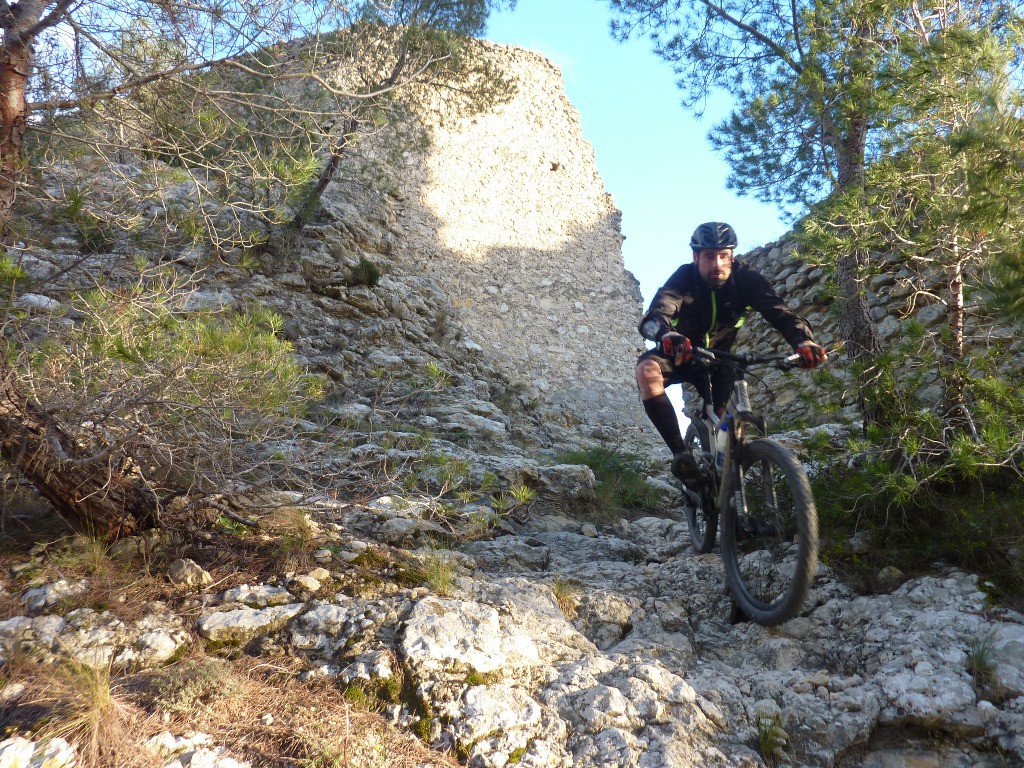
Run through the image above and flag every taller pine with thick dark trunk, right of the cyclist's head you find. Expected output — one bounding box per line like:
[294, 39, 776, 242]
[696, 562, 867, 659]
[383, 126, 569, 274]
[609, 0, 1020, 382]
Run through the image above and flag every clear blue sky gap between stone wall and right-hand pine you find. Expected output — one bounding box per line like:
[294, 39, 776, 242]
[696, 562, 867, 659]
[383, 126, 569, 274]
[485, 0, 788, 303]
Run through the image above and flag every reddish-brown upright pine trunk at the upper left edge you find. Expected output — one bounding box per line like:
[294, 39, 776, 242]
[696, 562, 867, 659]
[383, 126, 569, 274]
[0, 36, 32, 242]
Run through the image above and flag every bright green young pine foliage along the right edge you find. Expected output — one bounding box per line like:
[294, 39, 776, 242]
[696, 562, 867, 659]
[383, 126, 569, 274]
[786, 17, 1024, 593]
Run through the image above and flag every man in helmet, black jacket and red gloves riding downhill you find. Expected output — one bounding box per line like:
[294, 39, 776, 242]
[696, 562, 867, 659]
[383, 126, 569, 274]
[636, 221, 825, 484]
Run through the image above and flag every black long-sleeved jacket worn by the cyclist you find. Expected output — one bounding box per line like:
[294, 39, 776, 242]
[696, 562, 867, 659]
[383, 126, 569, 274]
[639, 259, 814, 350]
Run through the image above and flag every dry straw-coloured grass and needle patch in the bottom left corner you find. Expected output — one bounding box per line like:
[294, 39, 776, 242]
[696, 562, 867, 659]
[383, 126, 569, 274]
[0, 654, 459, 768]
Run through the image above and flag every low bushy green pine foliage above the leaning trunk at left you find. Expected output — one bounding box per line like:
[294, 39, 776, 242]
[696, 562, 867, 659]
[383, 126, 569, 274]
[11, 270, 324, 493]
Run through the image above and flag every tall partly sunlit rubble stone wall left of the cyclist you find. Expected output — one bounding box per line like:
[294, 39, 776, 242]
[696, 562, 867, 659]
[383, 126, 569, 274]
[326, 43, 647, 450]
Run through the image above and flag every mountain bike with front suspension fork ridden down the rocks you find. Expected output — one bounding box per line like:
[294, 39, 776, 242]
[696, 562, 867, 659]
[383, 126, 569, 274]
[682, 347, 818, 626]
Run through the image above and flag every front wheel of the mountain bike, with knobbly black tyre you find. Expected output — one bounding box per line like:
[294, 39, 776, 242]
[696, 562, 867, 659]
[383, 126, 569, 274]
[722, 439, 818, 626]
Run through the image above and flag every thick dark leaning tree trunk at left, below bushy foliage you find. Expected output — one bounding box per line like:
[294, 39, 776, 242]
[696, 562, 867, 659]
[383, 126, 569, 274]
[0, 358, 158, 539]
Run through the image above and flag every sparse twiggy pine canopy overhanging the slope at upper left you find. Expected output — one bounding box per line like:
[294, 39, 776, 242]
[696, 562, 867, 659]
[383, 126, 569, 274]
[6, 0, 514, 246]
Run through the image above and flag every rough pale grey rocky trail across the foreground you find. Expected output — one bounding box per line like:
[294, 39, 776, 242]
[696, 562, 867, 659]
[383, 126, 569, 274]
[0, 483, 1024, 768]
